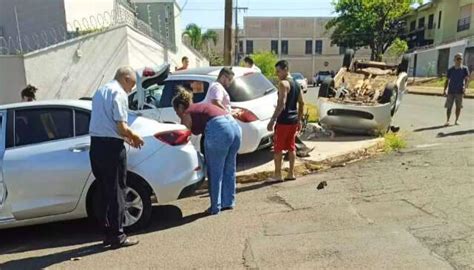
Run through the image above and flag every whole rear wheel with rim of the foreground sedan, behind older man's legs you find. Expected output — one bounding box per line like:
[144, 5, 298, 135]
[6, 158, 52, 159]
[87, 174, 152, 231]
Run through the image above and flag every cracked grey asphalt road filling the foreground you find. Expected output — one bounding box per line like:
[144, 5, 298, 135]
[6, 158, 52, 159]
[0, 95, 474, 270]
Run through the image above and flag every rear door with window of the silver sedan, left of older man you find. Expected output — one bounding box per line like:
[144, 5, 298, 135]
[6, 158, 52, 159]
[2, 107, 91, 220]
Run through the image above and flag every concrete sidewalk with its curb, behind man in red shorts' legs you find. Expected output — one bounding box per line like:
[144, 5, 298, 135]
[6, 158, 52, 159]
[237, 133, 384, 183]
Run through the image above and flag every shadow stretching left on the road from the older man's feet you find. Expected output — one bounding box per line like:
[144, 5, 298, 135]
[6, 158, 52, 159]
[0, 244, 108, 270]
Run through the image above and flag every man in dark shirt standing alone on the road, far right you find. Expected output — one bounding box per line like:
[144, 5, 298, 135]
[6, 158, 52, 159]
[444, 53, 469, 126]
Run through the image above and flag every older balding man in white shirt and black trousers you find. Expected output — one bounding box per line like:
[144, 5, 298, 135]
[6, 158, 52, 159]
[89, 67, 144, 249]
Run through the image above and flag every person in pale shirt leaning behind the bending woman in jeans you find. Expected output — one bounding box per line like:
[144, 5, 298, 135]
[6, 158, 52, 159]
[204, 67, 234, 113]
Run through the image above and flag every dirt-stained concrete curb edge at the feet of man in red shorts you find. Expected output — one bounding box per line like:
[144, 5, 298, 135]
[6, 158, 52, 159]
[236, 140, 384, 184]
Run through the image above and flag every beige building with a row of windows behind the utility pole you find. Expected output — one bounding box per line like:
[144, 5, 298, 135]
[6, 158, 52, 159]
[243, 17, 370, 81]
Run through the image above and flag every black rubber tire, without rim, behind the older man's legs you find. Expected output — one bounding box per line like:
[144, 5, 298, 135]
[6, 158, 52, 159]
[87, 174, 152, 232]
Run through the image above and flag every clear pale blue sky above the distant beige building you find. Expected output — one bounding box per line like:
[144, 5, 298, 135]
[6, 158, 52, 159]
[177, 0, 428, 29]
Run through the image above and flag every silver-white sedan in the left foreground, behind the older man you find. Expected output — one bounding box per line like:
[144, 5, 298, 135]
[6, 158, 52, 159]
[0, 100, 205, 230]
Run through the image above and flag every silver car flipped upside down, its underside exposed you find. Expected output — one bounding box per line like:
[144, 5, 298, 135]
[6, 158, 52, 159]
[317, 50, 409, 135]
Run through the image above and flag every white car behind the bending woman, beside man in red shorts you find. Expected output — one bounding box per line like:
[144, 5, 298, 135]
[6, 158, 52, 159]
[129, 66, 278, 154]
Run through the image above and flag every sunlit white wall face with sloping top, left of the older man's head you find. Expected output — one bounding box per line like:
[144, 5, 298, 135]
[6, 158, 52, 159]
[24, 26, 128, 99]
